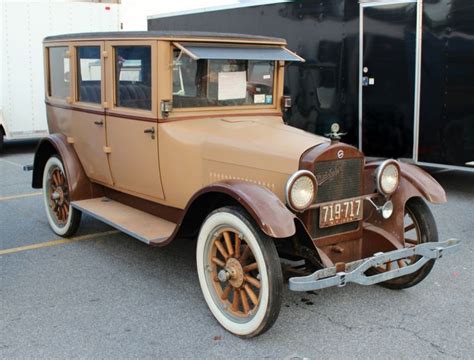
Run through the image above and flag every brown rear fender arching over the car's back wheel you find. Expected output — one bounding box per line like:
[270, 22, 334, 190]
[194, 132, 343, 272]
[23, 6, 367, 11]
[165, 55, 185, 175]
[32, 134, 101, 201]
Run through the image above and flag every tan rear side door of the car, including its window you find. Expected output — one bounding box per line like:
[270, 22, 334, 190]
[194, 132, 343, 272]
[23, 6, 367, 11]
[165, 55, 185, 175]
[70, 41, 113, 185]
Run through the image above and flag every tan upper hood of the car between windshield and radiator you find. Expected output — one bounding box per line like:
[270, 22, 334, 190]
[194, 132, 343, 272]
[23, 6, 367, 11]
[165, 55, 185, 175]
[171, 116, 328, 174]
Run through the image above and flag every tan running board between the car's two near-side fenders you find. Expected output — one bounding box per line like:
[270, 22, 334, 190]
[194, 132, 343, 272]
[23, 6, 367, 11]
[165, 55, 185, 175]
[71, 197, 176, 245]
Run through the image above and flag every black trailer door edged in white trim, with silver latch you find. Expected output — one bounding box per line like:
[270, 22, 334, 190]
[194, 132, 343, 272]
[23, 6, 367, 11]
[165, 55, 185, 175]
[359, 0, 421, 159]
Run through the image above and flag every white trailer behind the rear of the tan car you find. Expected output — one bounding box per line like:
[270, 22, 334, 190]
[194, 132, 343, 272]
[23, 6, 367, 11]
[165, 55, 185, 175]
[0, 0, 121, 151]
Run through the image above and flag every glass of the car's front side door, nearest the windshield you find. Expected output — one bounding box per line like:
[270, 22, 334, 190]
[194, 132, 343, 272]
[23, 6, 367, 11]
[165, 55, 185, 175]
[114, 46, 151, 110]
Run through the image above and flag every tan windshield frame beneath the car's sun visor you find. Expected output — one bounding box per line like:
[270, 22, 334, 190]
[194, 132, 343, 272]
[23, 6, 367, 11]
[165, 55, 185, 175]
[169, 42, 283, 114]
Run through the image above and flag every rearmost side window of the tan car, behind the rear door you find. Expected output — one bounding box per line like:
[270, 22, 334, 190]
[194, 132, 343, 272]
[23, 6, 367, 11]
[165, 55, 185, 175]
[48, 46, 71, 99]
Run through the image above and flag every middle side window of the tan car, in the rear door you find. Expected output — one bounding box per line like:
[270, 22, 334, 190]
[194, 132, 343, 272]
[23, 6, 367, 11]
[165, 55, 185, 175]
[76, 46, 102, 104]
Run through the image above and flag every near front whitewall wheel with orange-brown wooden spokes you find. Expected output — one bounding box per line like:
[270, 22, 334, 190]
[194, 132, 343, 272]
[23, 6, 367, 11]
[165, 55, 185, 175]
[196, 207, 283, 337]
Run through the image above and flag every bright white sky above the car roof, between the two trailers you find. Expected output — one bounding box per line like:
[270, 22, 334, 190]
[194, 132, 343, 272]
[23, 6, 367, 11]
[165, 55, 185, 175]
[120, 0, 245, 30]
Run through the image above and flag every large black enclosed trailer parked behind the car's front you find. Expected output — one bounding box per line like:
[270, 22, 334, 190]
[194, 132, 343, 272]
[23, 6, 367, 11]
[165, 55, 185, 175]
[148, 0, 474, 170]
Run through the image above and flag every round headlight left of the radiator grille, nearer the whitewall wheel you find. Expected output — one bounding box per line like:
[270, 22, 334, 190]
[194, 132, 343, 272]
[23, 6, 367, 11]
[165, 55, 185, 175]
[286, 170, 317, 211]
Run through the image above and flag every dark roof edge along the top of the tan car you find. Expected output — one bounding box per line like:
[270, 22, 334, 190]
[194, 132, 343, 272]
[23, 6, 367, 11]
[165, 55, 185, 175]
[44, 31, 286, 45]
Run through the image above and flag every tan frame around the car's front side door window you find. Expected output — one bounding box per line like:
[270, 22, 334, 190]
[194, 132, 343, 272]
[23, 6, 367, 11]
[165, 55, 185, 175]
[105, 40, 158, 119]
